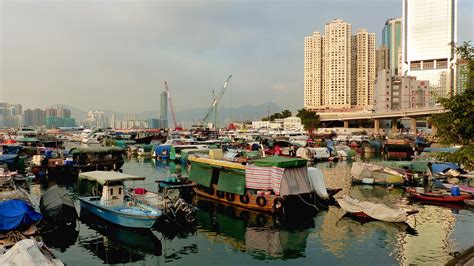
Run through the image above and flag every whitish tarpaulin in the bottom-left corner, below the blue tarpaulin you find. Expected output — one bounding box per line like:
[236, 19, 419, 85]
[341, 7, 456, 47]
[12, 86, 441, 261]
[0, 239, 64, 266]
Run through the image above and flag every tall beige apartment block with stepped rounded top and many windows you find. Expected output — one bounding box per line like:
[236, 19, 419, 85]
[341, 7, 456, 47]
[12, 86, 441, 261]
[304, 19, 376, 110]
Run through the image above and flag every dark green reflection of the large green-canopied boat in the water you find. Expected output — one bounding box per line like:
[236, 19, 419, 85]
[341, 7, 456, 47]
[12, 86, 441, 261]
[197, 199, 314, 260]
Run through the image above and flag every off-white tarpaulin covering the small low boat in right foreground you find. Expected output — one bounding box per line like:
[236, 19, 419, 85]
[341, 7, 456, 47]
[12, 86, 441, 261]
[337, 195, 407, 223]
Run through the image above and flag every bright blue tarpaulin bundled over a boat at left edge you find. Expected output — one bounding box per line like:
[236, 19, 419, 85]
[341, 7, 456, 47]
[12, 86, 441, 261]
[0, 199, 42, 231]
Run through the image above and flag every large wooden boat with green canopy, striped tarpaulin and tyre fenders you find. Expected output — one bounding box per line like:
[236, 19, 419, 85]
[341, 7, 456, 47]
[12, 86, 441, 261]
[189, 156, 326, 219]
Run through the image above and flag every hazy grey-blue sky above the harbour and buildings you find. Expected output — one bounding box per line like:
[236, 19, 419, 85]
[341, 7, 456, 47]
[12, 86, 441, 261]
[0, 0, 474, 112]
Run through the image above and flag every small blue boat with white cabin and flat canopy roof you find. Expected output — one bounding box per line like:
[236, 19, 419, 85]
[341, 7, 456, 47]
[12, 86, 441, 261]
[79, 171, 162, 228]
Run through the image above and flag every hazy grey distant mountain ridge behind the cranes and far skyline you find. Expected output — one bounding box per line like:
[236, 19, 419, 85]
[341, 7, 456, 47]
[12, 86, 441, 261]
[65, 102, 283, 125]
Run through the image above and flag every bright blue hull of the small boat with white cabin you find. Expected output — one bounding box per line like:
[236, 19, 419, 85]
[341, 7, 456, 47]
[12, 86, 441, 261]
[79, 197, 159, 228]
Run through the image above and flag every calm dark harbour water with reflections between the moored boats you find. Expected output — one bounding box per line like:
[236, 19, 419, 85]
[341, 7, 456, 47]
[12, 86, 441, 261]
[31, 158, 474, 265]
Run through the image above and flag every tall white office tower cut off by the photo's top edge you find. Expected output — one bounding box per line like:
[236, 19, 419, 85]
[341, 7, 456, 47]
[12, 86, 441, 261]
[402, 0, 457, 105]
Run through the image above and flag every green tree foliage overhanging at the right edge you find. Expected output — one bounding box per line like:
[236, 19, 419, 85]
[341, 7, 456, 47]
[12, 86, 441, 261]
[432, 42, 474, 145]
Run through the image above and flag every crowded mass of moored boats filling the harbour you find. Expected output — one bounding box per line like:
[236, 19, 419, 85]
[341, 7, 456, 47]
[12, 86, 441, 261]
[0, 128, 474, 265]
